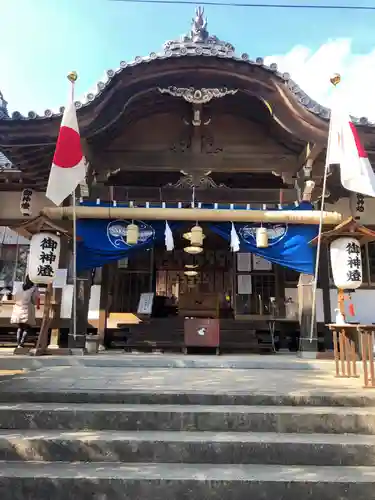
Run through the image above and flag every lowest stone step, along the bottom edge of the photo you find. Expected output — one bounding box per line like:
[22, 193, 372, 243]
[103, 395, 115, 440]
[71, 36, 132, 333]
[0, 462, 375, 500]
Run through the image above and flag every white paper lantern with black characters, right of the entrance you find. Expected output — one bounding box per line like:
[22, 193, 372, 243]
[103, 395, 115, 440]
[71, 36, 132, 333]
[330, 236, 362, 290]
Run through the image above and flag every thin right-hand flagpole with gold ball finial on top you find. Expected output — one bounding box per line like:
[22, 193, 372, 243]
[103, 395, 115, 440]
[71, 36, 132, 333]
[310, 74, 341, 343]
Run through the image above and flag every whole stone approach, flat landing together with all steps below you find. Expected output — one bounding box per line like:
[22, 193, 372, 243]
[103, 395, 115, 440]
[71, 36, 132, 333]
[0, 354, 375, 500]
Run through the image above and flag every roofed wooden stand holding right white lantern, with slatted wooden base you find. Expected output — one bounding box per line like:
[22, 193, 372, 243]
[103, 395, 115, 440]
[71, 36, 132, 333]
[310, 217, 375, 382]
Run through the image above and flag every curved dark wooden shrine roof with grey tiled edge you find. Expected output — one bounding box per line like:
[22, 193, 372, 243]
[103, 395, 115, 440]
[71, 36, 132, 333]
[0, 9, 375, 195]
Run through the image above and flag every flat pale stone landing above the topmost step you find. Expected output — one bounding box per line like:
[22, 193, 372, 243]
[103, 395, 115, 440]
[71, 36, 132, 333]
[0, 360, 375, 398]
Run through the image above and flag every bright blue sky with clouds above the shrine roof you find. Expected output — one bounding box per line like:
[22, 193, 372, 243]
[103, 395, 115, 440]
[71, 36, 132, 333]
[0, 0, 375, 117]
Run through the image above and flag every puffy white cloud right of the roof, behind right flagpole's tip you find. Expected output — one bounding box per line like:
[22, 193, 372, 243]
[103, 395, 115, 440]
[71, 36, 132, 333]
[265, 39, 375, 121]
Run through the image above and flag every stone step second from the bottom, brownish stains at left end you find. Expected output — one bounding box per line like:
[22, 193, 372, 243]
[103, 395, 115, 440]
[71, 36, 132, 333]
[0, 430, 375, 466]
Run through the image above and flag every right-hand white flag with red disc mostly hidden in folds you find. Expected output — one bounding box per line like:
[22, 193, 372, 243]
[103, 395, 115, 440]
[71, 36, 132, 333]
[326, 94, 375, 197]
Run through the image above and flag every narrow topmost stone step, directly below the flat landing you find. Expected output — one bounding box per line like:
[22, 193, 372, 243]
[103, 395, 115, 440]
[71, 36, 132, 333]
[0, 388, 375, 409]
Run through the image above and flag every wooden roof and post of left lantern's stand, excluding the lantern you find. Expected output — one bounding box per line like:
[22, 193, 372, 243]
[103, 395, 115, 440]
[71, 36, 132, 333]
[11, 215, 73, 356]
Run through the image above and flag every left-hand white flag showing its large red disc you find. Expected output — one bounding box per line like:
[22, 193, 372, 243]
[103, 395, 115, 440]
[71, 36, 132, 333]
[46, 100, 86, 205]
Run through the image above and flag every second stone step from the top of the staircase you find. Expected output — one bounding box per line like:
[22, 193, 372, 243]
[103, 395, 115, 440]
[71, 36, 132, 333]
[0, 403, 375, 435]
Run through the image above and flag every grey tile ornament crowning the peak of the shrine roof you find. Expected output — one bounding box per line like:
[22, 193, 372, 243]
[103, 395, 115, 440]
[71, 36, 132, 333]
[164, 7, 234, 57]
